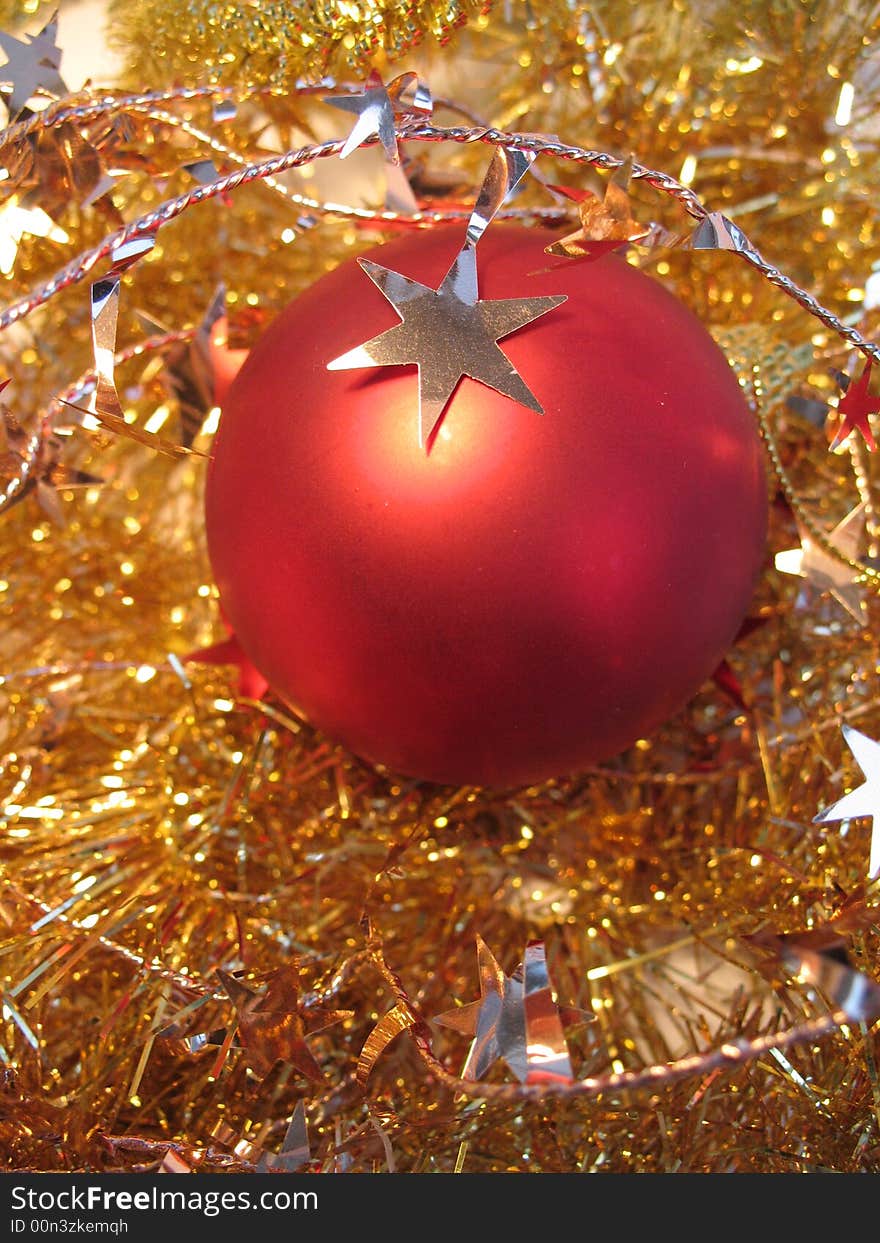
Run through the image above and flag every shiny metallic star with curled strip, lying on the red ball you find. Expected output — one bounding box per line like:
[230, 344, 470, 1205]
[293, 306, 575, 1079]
[327, 149, 566, 447]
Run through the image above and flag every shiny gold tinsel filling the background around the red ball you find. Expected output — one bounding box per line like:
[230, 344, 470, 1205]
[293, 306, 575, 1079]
[0, 0, 880, 1172]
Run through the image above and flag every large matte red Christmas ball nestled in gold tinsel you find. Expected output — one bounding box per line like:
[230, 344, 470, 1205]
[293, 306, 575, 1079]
[206, 224, 767, 786]
